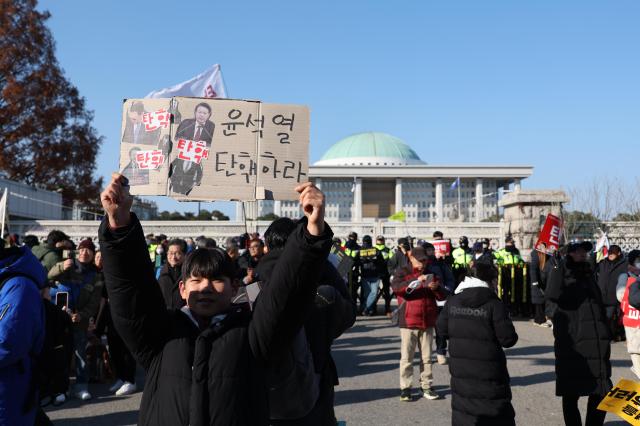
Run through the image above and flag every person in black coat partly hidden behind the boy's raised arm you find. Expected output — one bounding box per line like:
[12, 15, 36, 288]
[257, 217, 356, 426]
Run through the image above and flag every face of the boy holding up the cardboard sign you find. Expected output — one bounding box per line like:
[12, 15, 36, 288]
[179, 275, 233, 318]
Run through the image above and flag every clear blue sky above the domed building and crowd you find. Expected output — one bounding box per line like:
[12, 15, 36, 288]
[39, 0, 640, 218]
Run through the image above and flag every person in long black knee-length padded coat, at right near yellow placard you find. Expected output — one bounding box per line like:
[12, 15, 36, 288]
[545, 242, 611, 425]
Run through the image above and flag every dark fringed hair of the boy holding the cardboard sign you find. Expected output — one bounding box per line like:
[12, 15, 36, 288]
[182, 248, 236, 281]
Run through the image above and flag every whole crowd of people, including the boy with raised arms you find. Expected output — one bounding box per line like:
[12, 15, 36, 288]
[0, 176, 640, 425]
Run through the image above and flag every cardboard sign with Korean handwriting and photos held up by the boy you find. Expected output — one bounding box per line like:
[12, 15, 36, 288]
[120, 97, 309, 201]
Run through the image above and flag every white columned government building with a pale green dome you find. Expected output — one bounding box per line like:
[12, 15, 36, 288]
[236, 132, 533, 223]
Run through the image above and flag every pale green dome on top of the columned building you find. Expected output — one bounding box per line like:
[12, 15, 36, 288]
[315, 132, 425, 166]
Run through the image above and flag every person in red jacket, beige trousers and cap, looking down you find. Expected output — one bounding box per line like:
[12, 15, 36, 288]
[391, 247, 446, 401]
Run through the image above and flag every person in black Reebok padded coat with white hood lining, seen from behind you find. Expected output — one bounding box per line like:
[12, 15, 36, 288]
[437, 262, 518, 426]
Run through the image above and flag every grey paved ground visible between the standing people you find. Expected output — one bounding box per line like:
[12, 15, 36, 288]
[47, 317, 633, 426]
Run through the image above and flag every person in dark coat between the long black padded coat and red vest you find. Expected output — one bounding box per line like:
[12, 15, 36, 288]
[597, 245, 629, 341]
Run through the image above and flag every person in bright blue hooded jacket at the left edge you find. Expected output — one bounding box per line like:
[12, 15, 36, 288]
[0, 242, 47, 426]
